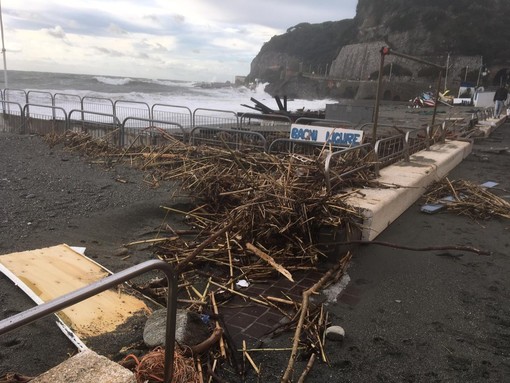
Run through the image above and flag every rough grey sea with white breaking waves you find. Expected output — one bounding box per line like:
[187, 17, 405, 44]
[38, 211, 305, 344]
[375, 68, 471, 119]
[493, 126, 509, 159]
[0, 70, 336, 113]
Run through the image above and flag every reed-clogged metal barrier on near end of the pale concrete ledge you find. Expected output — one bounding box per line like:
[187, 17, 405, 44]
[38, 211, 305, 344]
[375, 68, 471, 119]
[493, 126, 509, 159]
[324, 143, 375, 193]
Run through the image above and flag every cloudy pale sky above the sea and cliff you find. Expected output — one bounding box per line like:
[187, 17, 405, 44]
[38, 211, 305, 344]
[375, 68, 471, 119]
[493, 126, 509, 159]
[0, 0, 357, 82]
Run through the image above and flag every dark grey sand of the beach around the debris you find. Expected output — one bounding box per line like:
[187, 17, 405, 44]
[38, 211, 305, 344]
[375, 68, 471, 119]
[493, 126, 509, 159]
[0, 106, 510, 382]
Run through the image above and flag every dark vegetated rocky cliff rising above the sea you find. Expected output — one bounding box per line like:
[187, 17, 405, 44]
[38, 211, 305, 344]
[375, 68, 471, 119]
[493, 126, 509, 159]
[248, 0, 510, 97]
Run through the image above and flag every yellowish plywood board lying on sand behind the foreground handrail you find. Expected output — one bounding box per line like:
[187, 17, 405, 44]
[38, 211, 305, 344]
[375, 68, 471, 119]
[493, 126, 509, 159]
[0, 245, 149, 339]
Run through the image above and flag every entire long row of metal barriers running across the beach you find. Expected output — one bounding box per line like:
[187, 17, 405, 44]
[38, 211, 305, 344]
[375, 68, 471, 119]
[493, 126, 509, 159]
[0, 89, 472, 189]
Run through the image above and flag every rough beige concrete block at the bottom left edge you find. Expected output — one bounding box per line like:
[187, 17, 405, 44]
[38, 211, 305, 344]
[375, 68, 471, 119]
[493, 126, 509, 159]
[30, 350, 136, 383]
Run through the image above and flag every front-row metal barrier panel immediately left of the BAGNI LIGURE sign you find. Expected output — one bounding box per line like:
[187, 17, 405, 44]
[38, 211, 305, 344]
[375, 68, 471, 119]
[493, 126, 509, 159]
[190, 126, 267, 152]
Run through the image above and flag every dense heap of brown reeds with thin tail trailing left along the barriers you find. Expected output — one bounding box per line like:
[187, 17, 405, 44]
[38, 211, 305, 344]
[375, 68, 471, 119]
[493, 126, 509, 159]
[47, 131, 374, 278]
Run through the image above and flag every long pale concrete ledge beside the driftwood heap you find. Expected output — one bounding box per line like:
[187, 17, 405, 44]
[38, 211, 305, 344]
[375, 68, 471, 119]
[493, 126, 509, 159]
[346, 141, 473, 241]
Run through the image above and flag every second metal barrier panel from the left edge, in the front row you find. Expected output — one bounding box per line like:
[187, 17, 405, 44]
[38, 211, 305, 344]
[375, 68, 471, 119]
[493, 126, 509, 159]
[22, 104, 68, 134]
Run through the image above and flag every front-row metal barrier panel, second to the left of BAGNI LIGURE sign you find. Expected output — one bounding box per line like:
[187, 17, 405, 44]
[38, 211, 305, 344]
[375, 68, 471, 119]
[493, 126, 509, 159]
[122, 117, 189, 147]
